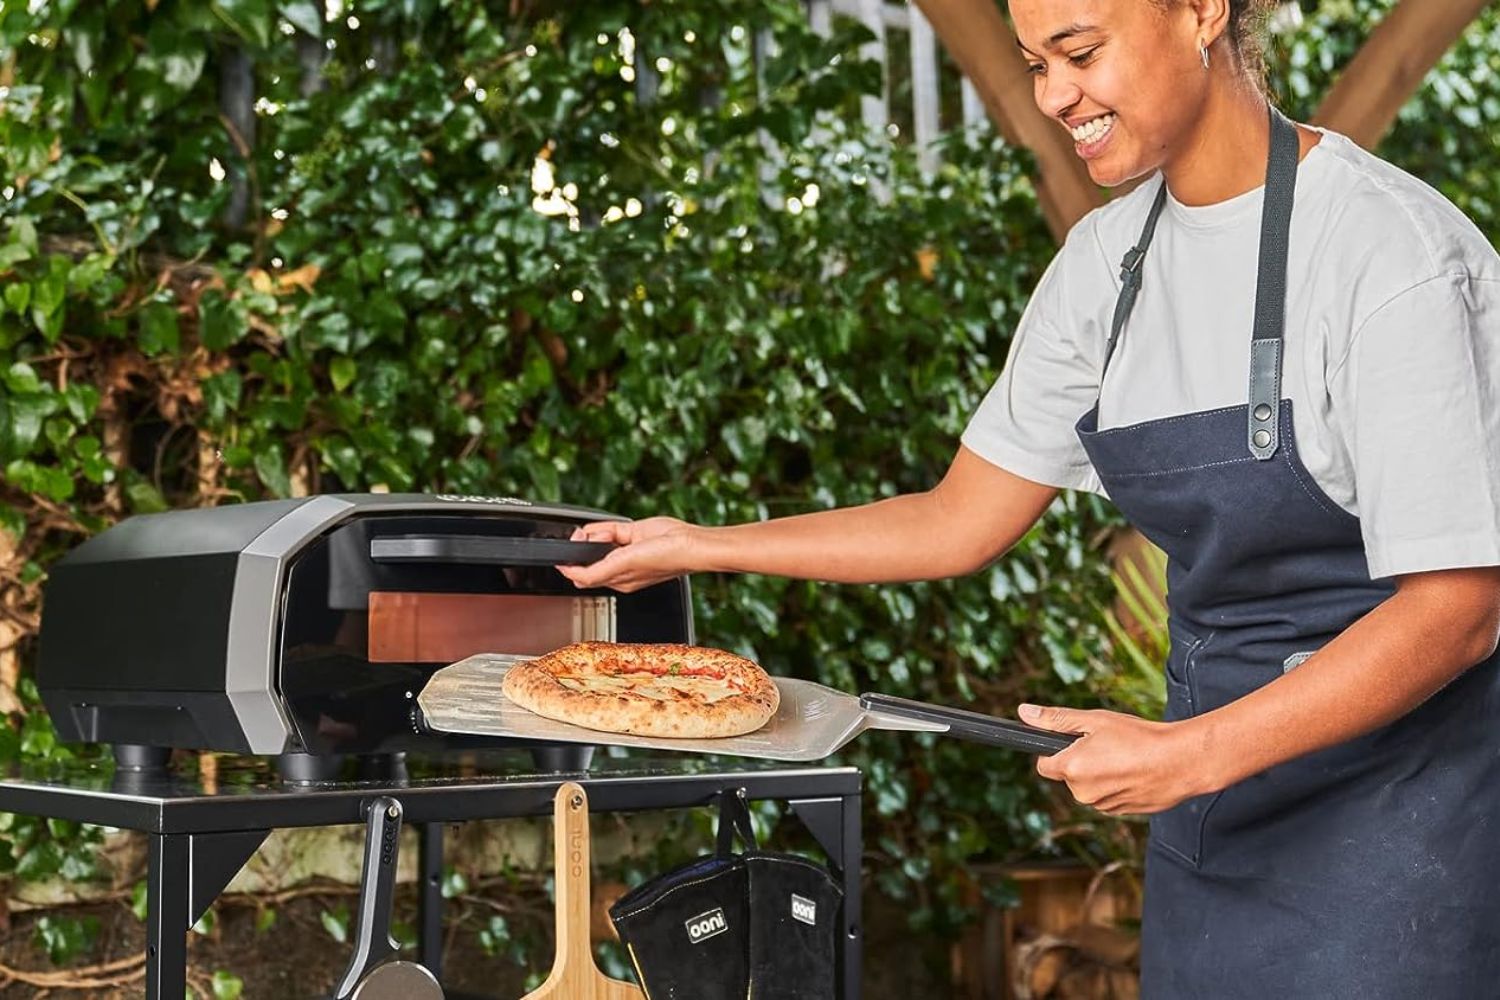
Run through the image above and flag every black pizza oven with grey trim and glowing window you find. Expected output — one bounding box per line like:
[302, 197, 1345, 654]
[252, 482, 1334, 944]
[36, 495, 693, 760]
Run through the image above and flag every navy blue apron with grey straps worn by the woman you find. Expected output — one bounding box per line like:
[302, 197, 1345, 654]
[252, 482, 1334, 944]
[1077, 111, 1500, 1000]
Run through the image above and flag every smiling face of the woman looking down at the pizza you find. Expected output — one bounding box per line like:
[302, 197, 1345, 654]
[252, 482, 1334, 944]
[1010, 0, 1208, 186]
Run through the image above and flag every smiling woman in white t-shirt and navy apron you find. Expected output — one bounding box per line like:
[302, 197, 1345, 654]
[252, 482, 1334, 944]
[567, 0, 1500, 1000]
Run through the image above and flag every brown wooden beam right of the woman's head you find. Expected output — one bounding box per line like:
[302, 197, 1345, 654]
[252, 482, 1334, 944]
[1313, 0, 1490, 148]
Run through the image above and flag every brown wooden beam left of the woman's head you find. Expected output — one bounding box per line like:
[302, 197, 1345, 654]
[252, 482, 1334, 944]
[915, 0, 1104, 243]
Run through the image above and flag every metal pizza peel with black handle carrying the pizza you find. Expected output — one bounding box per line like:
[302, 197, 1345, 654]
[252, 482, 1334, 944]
[416, 654, 1076, 762]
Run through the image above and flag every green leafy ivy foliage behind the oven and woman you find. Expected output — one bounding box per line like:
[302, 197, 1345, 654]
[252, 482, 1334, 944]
[0, 0, 1500, 989]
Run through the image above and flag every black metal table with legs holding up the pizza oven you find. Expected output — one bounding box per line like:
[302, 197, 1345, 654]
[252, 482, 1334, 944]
[0, 751, 863, 1000]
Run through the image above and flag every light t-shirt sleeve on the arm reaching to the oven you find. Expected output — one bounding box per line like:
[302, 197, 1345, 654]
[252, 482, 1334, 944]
[962, 232, 1112, 493]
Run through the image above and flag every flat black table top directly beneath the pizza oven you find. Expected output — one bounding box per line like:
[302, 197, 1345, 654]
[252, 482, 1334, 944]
[0, 748, 861, 834]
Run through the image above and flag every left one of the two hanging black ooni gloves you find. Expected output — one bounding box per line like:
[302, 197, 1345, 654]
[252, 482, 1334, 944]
[609, 796, 755, 1000]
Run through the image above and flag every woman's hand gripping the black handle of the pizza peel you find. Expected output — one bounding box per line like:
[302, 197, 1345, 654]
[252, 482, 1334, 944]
[1020, 705, 1218, 816]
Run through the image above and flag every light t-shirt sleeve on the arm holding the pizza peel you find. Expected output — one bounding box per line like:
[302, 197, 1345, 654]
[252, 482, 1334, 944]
[1329, 273, 1500, 579]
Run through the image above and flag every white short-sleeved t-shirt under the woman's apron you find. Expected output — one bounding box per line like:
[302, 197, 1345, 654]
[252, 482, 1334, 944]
[963, 130, 1500, 577]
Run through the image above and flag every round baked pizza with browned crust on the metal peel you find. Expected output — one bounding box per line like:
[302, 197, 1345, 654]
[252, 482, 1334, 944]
[501, 642, 782, 739]
